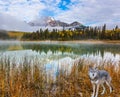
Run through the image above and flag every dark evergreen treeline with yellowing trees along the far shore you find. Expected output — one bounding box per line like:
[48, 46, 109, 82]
[22, 24, 120, 41]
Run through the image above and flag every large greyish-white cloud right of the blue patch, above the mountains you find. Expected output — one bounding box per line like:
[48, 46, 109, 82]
[56, 0, 120, 25]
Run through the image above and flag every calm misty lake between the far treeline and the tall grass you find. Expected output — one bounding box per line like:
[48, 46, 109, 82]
[0, 41, 120, 74]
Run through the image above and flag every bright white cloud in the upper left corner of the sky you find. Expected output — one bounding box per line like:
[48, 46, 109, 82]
[0, 0, 45, 21]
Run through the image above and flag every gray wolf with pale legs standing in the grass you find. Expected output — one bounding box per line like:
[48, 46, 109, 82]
[88, 67, 113, 97]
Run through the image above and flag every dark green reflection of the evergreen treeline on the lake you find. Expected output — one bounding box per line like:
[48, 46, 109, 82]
[23, 44, 120, 57]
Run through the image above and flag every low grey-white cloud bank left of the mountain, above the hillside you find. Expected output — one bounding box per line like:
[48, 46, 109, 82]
[0, 13, 31, 31]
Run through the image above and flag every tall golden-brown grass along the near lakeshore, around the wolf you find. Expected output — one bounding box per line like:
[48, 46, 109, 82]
[0, 58, 120, 97]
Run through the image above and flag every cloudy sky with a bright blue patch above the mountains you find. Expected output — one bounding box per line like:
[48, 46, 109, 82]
[0, 0, 120, 29]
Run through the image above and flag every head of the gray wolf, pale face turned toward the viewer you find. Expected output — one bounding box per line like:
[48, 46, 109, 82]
[88, 67, 98, 80]
